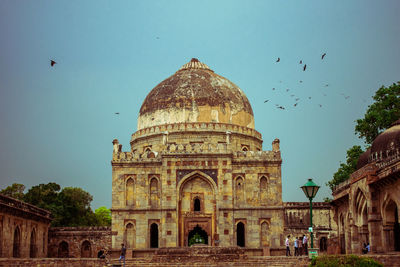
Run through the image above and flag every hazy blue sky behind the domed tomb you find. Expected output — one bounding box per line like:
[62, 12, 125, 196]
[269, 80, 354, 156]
[0, 0, 400, 208]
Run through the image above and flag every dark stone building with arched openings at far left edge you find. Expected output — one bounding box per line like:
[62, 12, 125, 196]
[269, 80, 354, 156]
[0, 195, 51, 258]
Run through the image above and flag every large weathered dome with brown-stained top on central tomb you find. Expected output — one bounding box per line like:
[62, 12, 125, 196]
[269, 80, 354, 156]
[137, 58, 254, 130]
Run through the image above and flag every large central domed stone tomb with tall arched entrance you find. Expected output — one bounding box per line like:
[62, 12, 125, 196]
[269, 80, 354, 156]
[111, 59, 284, 251]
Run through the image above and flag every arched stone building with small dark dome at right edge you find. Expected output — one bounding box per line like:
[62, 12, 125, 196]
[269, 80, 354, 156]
[333, 120, 400, 254]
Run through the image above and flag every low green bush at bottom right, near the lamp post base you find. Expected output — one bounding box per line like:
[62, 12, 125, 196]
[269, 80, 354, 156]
[310, 255, 383, 267]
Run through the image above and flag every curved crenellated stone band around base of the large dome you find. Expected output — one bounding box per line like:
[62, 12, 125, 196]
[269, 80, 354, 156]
[131, 122, 261, 142]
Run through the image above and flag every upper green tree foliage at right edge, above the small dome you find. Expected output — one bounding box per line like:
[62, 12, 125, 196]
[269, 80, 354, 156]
[355, 82, 400, 144]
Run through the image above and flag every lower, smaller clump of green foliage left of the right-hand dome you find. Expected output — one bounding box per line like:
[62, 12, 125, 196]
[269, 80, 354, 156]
[326, 146, 364, 190]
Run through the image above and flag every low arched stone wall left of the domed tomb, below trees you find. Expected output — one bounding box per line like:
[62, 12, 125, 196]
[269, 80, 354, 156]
[48, 227, 111, 258]
